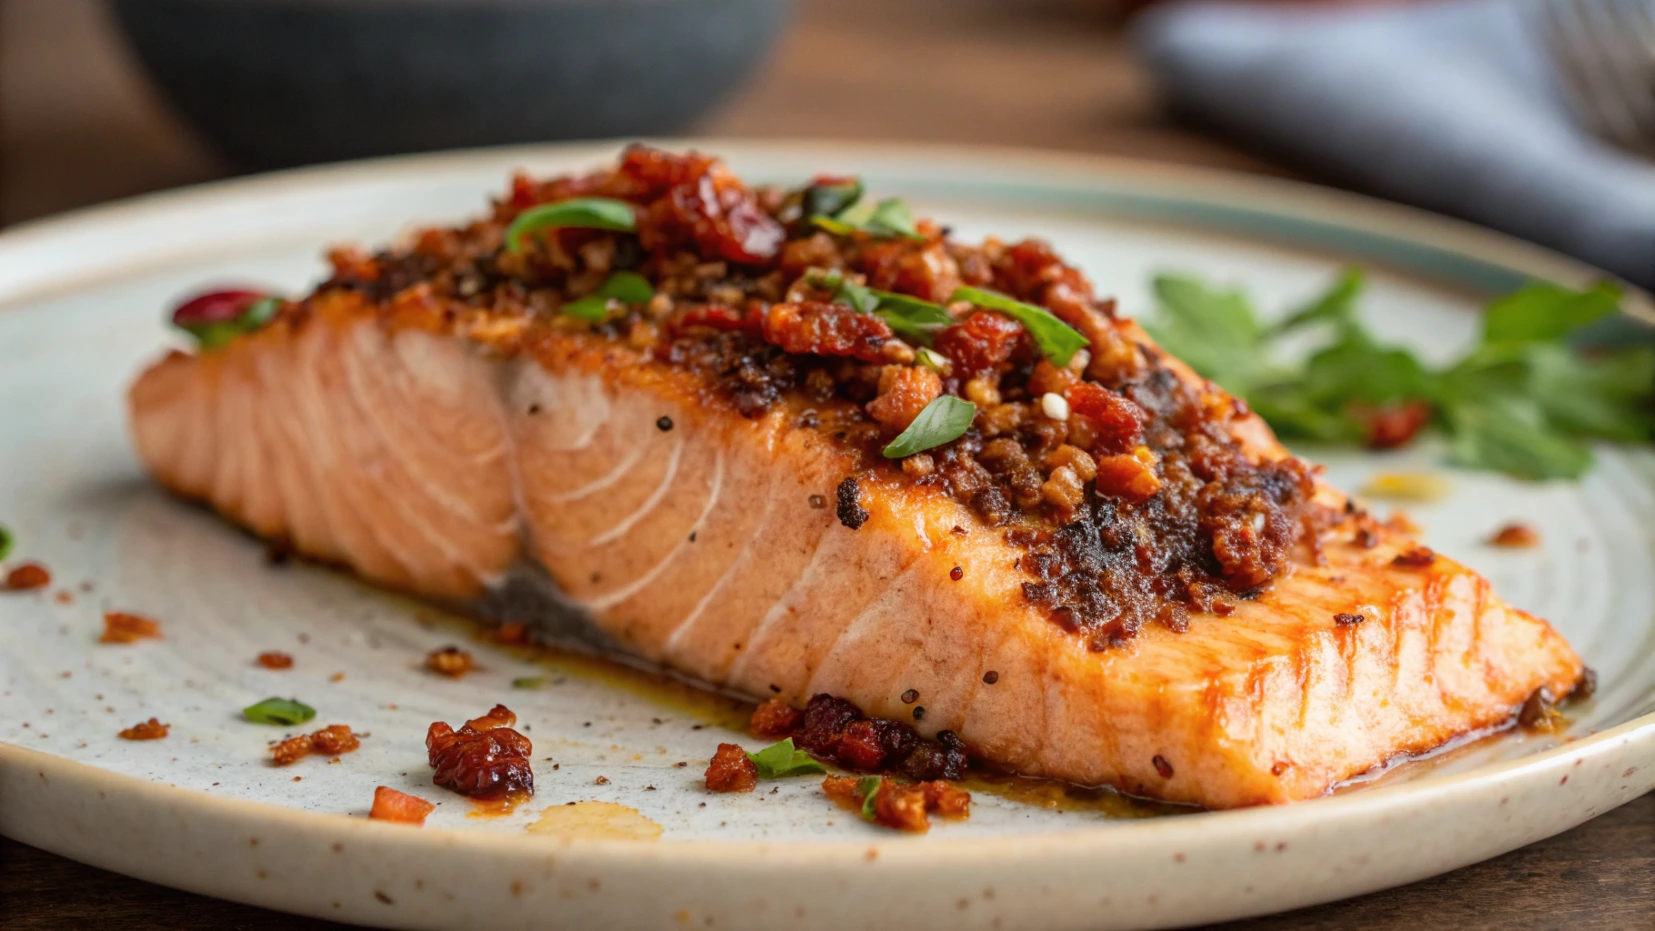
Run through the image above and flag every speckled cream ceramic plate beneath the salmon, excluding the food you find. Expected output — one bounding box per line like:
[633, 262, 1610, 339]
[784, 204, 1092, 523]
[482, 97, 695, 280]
[0, 144, 1655, 928]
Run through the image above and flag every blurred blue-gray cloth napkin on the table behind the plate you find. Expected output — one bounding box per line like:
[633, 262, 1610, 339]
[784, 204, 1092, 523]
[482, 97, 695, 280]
[1134, 0, 1655, 289]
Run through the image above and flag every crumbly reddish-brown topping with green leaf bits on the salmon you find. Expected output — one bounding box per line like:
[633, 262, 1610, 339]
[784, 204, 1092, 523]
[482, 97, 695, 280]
[301, 146, 1331, 650]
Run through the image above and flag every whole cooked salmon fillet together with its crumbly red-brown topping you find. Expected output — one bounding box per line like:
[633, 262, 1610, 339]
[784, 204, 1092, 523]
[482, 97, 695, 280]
[129, 147, 1584, 809]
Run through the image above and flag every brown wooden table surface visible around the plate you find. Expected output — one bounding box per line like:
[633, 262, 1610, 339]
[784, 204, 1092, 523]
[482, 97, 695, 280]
[0, 0, 1655, 931]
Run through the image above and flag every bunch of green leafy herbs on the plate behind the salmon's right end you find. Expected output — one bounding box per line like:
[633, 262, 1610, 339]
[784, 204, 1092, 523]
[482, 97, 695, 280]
[1147, 271, 1655, 480]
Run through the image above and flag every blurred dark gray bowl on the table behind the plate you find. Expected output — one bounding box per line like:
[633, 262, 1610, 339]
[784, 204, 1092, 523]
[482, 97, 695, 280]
[113, 0, 791, 169]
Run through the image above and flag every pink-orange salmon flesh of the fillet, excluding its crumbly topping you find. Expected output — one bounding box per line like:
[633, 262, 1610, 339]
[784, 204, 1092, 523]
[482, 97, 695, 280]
[129, 147, 1584, 809]
